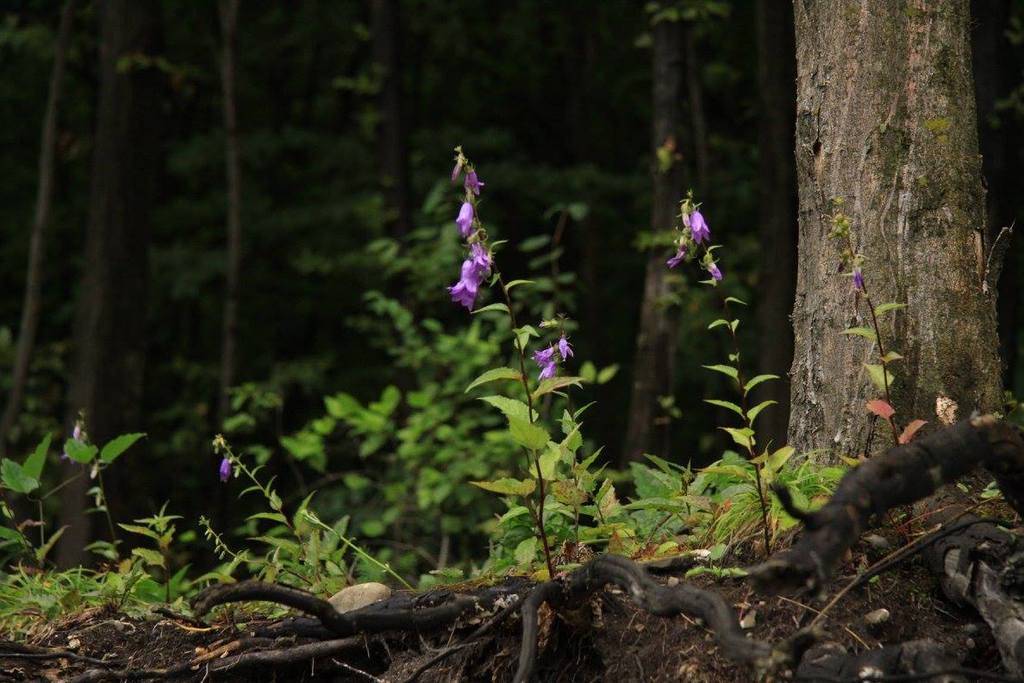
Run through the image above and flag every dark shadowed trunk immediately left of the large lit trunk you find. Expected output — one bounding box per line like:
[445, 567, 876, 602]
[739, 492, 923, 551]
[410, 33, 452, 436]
[757, 0, 797, 454]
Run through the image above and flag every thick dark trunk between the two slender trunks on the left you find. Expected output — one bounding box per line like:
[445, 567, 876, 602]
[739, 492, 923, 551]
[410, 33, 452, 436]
[58, 0, 161, 566]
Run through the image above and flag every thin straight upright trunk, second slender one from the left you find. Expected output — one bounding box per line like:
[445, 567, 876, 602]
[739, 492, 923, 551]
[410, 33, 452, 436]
[217, 0, 242, 428]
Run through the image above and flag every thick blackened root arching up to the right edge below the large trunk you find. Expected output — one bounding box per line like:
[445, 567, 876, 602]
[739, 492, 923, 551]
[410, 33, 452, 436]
[751, 416, 1024, 592]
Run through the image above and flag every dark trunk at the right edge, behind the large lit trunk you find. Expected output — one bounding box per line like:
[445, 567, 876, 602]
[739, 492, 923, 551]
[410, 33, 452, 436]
[971, 0, 1021, 387]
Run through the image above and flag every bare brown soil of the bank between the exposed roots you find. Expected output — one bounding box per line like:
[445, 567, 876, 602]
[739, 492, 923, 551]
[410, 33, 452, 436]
[0, 535, 999, 683]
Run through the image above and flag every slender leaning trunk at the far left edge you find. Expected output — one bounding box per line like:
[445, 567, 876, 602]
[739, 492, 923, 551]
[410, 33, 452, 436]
[0, 0, 75, 457]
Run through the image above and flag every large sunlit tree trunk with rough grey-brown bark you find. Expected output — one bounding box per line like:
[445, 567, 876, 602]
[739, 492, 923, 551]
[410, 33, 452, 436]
[790, 0, 1000, 455]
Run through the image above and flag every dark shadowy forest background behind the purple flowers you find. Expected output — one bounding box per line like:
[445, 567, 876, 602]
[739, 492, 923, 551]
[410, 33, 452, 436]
[0, 0, 1024, 573]
